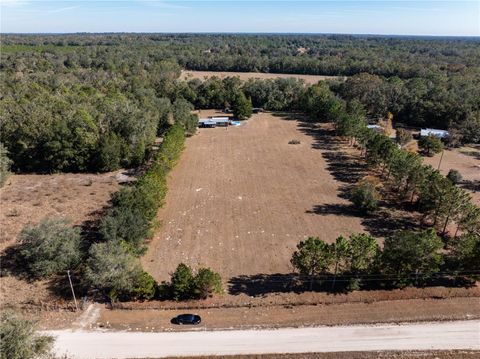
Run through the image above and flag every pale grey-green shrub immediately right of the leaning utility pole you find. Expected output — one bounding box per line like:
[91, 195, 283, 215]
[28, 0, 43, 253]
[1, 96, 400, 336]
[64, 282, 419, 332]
[85, 241, 143, 302]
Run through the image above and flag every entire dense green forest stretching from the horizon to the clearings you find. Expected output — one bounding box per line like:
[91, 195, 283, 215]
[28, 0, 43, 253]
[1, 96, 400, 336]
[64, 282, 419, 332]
[0, 34, 480, 172]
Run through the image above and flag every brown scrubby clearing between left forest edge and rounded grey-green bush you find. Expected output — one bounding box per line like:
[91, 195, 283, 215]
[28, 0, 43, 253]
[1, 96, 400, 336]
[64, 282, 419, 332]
[0, 172, 118, 250]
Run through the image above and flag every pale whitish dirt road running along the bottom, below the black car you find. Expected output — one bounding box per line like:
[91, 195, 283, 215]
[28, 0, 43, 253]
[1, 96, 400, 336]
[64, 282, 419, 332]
[49, 321, 480, 359]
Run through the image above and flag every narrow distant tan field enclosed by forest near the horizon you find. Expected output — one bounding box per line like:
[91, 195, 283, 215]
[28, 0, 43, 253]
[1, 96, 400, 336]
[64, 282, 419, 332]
[180, 70, 343, 85]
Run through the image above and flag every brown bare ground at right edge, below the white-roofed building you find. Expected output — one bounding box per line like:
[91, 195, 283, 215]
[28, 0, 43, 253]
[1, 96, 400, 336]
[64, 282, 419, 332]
[424, 148, 480, 206]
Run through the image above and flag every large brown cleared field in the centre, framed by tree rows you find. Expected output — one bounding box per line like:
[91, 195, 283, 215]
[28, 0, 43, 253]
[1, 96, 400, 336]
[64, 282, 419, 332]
[142, 111, 363, 280]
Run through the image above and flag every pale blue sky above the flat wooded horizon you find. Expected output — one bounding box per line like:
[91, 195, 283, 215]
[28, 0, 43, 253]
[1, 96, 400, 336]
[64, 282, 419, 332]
[0, 0, 480, 36]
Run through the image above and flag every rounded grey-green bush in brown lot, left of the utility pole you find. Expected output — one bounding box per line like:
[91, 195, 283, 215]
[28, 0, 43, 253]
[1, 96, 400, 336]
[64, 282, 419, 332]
[18, 218, 81, 278]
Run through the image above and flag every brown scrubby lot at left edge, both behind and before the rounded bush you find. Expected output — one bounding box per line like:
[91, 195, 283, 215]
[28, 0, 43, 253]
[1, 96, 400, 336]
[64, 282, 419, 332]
[0, 172, 119, 325]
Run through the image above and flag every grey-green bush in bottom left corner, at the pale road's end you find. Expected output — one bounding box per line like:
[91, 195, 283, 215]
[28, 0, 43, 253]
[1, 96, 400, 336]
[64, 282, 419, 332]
[0, 311, 54, 359]
